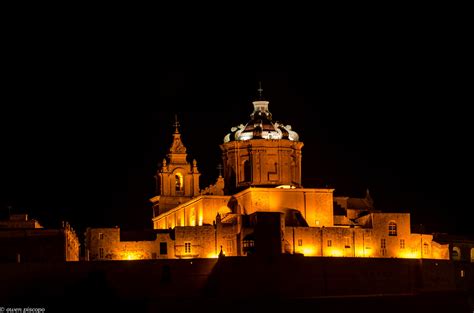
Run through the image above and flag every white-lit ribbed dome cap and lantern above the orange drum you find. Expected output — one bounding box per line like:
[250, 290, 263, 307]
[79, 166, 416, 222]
[224, 100, 299, 143]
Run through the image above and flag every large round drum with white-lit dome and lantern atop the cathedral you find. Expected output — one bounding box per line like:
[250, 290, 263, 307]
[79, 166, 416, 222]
[220, 87, 303, 193]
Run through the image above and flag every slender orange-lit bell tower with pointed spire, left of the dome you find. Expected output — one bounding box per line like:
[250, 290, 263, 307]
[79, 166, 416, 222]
[150, 118, 201, 216]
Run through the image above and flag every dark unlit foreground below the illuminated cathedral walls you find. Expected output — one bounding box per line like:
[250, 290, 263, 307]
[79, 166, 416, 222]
[0, 256, 474, 313]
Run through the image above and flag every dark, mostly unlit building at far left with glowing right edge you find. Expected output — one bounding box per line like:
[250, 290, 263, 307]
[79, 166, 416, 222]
[0, 214, 80, 263]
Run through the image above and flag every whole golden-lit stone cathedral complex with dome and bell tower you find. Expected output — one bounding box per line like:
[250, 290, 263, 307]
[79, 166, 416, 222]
[86, 89, 449, 260]
